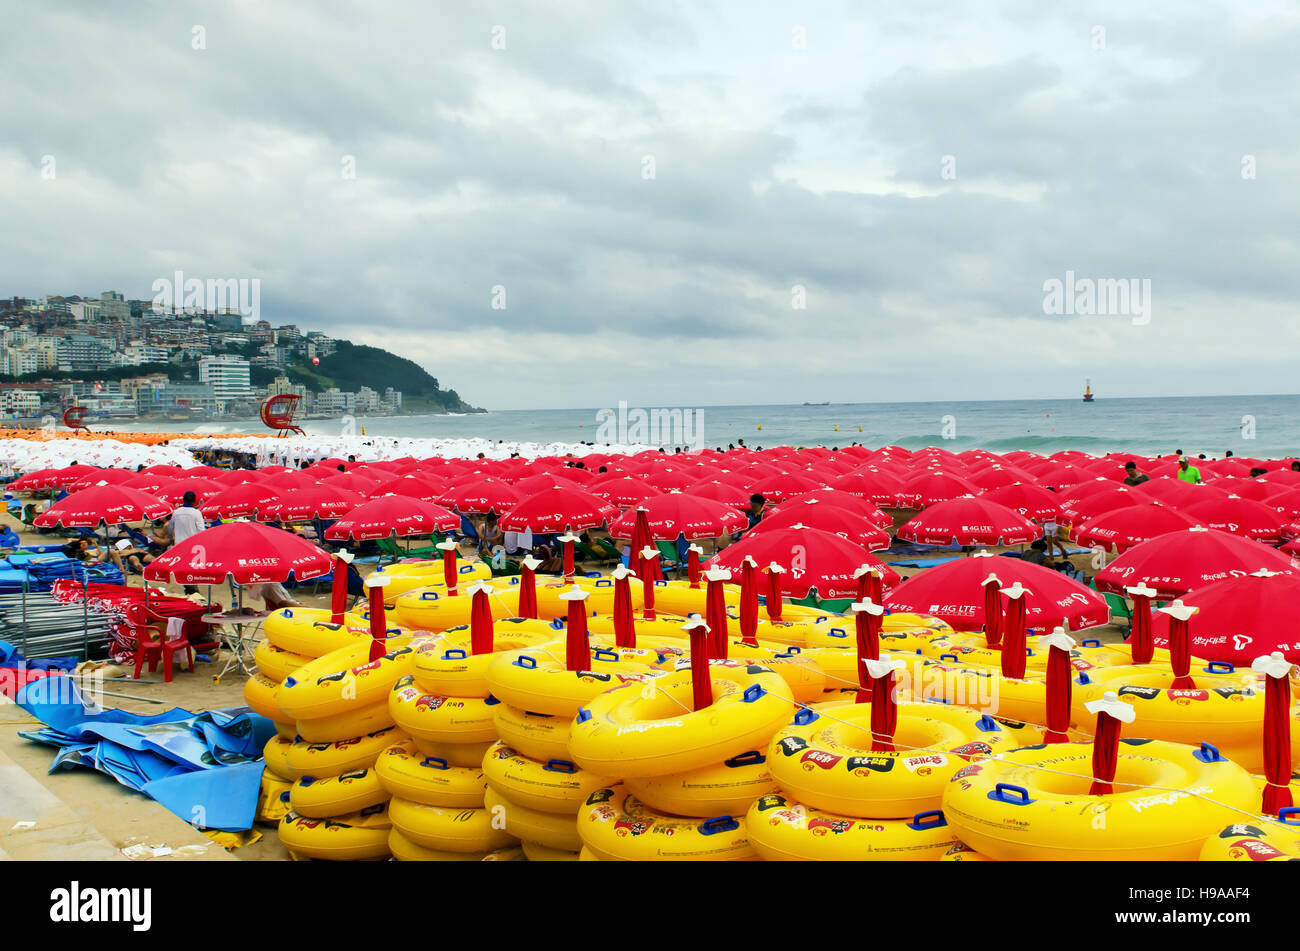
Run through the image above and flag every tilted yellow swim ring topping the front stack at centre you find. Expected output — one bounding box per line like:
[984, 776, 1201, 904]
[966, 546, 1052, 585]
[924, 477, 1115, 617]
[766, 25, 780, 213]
[569, 660, 790, 777]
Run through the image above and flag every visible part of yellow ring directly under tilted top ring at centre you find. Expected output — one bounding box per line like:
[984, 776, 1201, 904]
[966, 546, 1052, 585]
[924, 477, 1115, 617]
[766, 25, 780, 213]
[623, 750, 776, 818]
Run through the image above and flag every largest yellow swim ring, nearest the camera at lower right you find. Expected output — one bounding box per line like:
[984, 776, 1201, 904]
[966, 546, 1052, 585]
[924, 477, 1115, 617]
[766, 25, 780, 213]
[943, 738, 1258, 861]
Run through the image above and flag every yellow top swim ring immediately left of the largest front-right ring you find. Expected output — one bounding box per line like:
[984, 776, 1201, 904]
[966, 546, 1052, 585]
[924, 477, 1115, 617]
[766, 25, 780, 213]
[767, 702, 1043, 818]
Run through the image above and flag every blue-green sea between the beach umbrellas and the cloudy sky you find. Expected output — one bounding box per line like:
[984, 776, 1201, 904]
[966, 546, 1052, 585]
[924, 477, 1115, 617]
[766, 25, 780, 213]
[94, 395, 1300, 457]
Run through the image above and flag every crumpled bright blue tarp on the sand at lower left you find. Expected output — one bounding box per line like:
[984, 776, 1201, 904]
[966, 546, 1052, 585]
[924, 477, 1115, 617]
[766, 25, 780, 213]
[18, 681, 276, 831]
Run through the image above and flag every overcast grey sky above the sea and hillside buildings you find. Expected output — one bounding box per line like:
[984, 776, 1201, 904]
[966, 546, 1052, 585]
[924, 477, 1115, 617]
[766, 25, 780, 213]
[0, 0, 1300, 409]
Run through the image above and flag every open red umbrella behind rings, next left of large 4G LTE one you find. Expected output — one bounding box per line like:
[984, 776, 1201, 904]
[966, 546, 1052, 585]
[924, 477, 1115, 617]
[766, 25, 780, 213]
[706, 529, 899, 598]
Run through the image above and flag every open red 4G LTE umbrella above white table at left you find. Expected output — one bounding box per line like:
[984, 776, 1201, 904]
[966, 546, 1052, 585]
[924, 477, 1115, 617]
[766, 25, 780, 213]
[144, 522, 333, 585]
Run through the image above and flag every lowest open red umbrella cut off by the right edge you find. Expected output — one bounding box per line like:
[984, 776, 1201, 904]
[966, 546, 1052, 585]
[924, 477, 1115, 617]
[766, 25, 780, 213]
[1151, 570, 1300, 668]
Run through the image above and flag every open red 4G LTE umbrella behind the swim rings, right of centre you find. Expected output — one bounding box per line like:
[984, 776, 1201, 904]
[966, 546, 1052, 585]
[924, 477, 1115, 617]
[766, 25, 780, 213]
[885, 552, 1110, 630]
